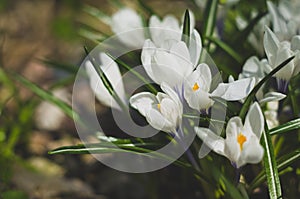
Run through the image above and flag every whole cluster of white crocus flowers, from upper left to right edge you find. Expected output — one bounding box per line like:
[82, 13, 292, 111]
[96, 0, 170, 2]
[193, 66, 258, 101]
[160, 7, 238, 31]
[86, 2, 300, 168]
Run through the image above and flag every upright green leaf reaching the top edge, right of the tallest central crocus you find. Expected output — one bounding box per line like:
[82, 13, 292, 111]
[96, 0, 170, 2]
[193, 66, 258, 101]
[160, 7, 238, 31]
[203, 0, 218, 51]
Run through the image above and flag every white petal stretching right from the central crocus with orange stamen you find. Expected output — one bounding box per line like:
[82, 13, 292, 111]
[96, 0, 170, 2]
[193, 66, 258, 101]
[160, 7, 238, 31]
[212, 78, 255, 101]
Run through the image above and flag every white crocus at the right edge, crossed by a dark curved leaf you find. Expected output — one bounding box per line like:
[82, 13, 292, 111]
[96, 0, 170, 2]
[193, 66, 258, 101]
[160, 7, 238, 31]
[264, 27, 300, 81]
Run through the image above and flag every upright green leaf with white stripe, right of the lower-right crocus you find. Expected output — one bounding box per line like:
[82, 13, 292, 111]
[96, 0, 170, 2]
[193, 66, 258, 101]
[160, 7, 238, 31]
[262, 119, 282, 199]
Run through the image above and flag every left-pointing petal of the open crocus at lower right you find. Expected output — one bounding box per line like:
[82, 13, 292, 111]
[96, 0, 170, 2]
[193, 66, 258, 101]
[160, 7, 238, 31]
[194, 127, 225, 155]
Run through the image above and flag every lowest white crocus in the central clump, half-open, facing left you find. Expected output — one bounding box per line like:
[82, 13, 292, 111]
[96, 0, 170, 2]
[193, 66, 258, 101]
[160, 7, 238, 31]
[129, 83, 183, 133]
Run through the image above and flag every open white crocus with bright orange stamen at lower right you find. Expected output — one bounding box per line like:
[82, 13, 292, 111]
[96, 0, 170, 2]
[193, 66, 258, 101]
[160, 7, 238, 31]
[195, 103, 264, 168]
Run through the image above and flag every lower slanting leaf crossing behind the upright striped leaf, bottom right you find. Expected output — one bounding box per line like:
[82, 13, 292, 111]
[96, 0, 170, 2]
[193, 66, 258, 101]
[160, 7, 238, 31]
[249, 149, 300, 192]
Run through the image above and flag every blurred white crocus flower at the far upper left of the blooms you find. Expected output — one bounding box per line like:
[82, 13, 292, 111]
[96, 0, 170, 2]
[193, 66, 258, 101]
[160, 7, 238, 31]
[111, 8, 146, 48]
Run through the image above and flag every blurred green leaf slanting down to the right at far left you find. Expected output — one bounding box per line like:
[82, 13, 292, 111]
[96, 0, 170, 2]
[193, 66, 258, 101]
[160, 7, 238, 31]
[13, 74, 80, 122]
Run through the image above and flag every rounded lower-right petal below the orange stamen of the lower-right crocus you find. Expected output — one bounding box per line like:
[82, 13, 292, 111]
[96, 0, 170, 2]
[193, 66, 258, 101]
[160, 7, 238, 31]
[236, 135, 264, 168]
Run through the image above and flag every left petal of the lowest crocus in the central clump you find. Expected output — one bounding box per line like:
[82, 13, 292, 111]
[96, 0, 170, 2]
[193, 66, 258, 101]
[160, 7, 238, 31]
[129, 92, 157, 116]
